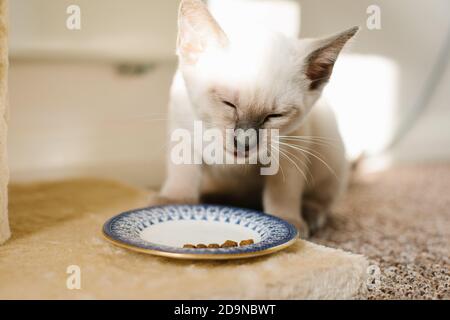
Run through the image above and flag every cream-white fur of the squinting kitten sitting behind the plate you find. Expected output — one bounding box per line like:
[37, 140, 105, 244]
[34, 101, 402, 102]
[151, 0, 358, 237]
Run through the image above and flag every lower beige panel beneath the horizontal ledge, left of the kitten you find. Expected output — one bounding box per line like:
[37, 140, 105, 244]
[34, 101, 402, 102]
[8, 60, 175, 186]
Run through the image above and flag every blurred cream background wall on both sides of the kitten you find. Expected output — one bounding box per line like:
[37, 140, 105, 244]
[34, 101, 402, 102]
[9, 0, 450, 187]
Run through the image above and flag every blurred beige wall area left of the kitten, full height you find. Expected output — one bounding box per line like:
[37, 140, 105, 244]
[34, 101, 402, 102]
[9, 0, 179, 187]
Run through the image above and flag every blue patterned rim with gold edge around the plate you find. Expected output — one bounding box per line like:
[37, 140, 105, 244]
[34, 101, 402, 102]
[102, 204, 299, 260]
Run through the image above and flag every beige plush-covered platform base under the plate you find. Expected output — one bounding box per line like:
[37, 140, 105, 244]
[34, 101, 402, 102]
[0, 180, 367, 299]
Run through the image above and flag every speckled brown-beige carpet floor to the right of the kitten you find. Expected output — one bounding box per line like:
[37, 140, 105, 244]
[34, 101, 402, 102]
[312, 165, 450, 299]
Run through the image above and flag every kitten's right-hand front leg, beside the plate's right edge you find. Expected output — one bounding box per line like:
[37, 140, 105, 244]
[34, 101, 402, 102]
[263, 159, 309, 239]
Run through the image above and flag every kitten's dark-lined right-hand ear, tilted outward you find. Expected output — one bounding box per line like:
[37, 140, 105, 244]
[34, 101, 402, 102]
[305, 27, 359, 90]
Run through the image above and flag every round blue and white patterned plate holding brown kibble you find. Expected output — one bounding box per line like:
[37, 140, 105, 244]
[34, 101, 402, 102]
[103, 205, 298, 260]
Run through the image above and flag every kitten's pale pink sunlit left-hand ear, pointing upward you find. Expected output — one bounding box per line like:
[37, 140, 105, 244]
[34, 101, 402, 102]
[177, 0, 228, 64]
